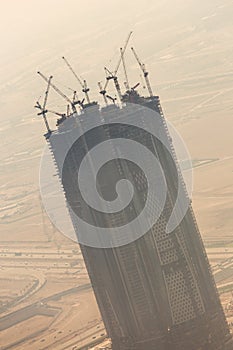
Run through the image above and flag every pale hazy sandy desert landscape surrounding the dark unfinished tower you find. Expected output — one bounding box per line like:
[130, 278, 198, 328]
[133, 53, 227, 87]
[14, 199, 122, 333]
[0, 0, 233, 350]
